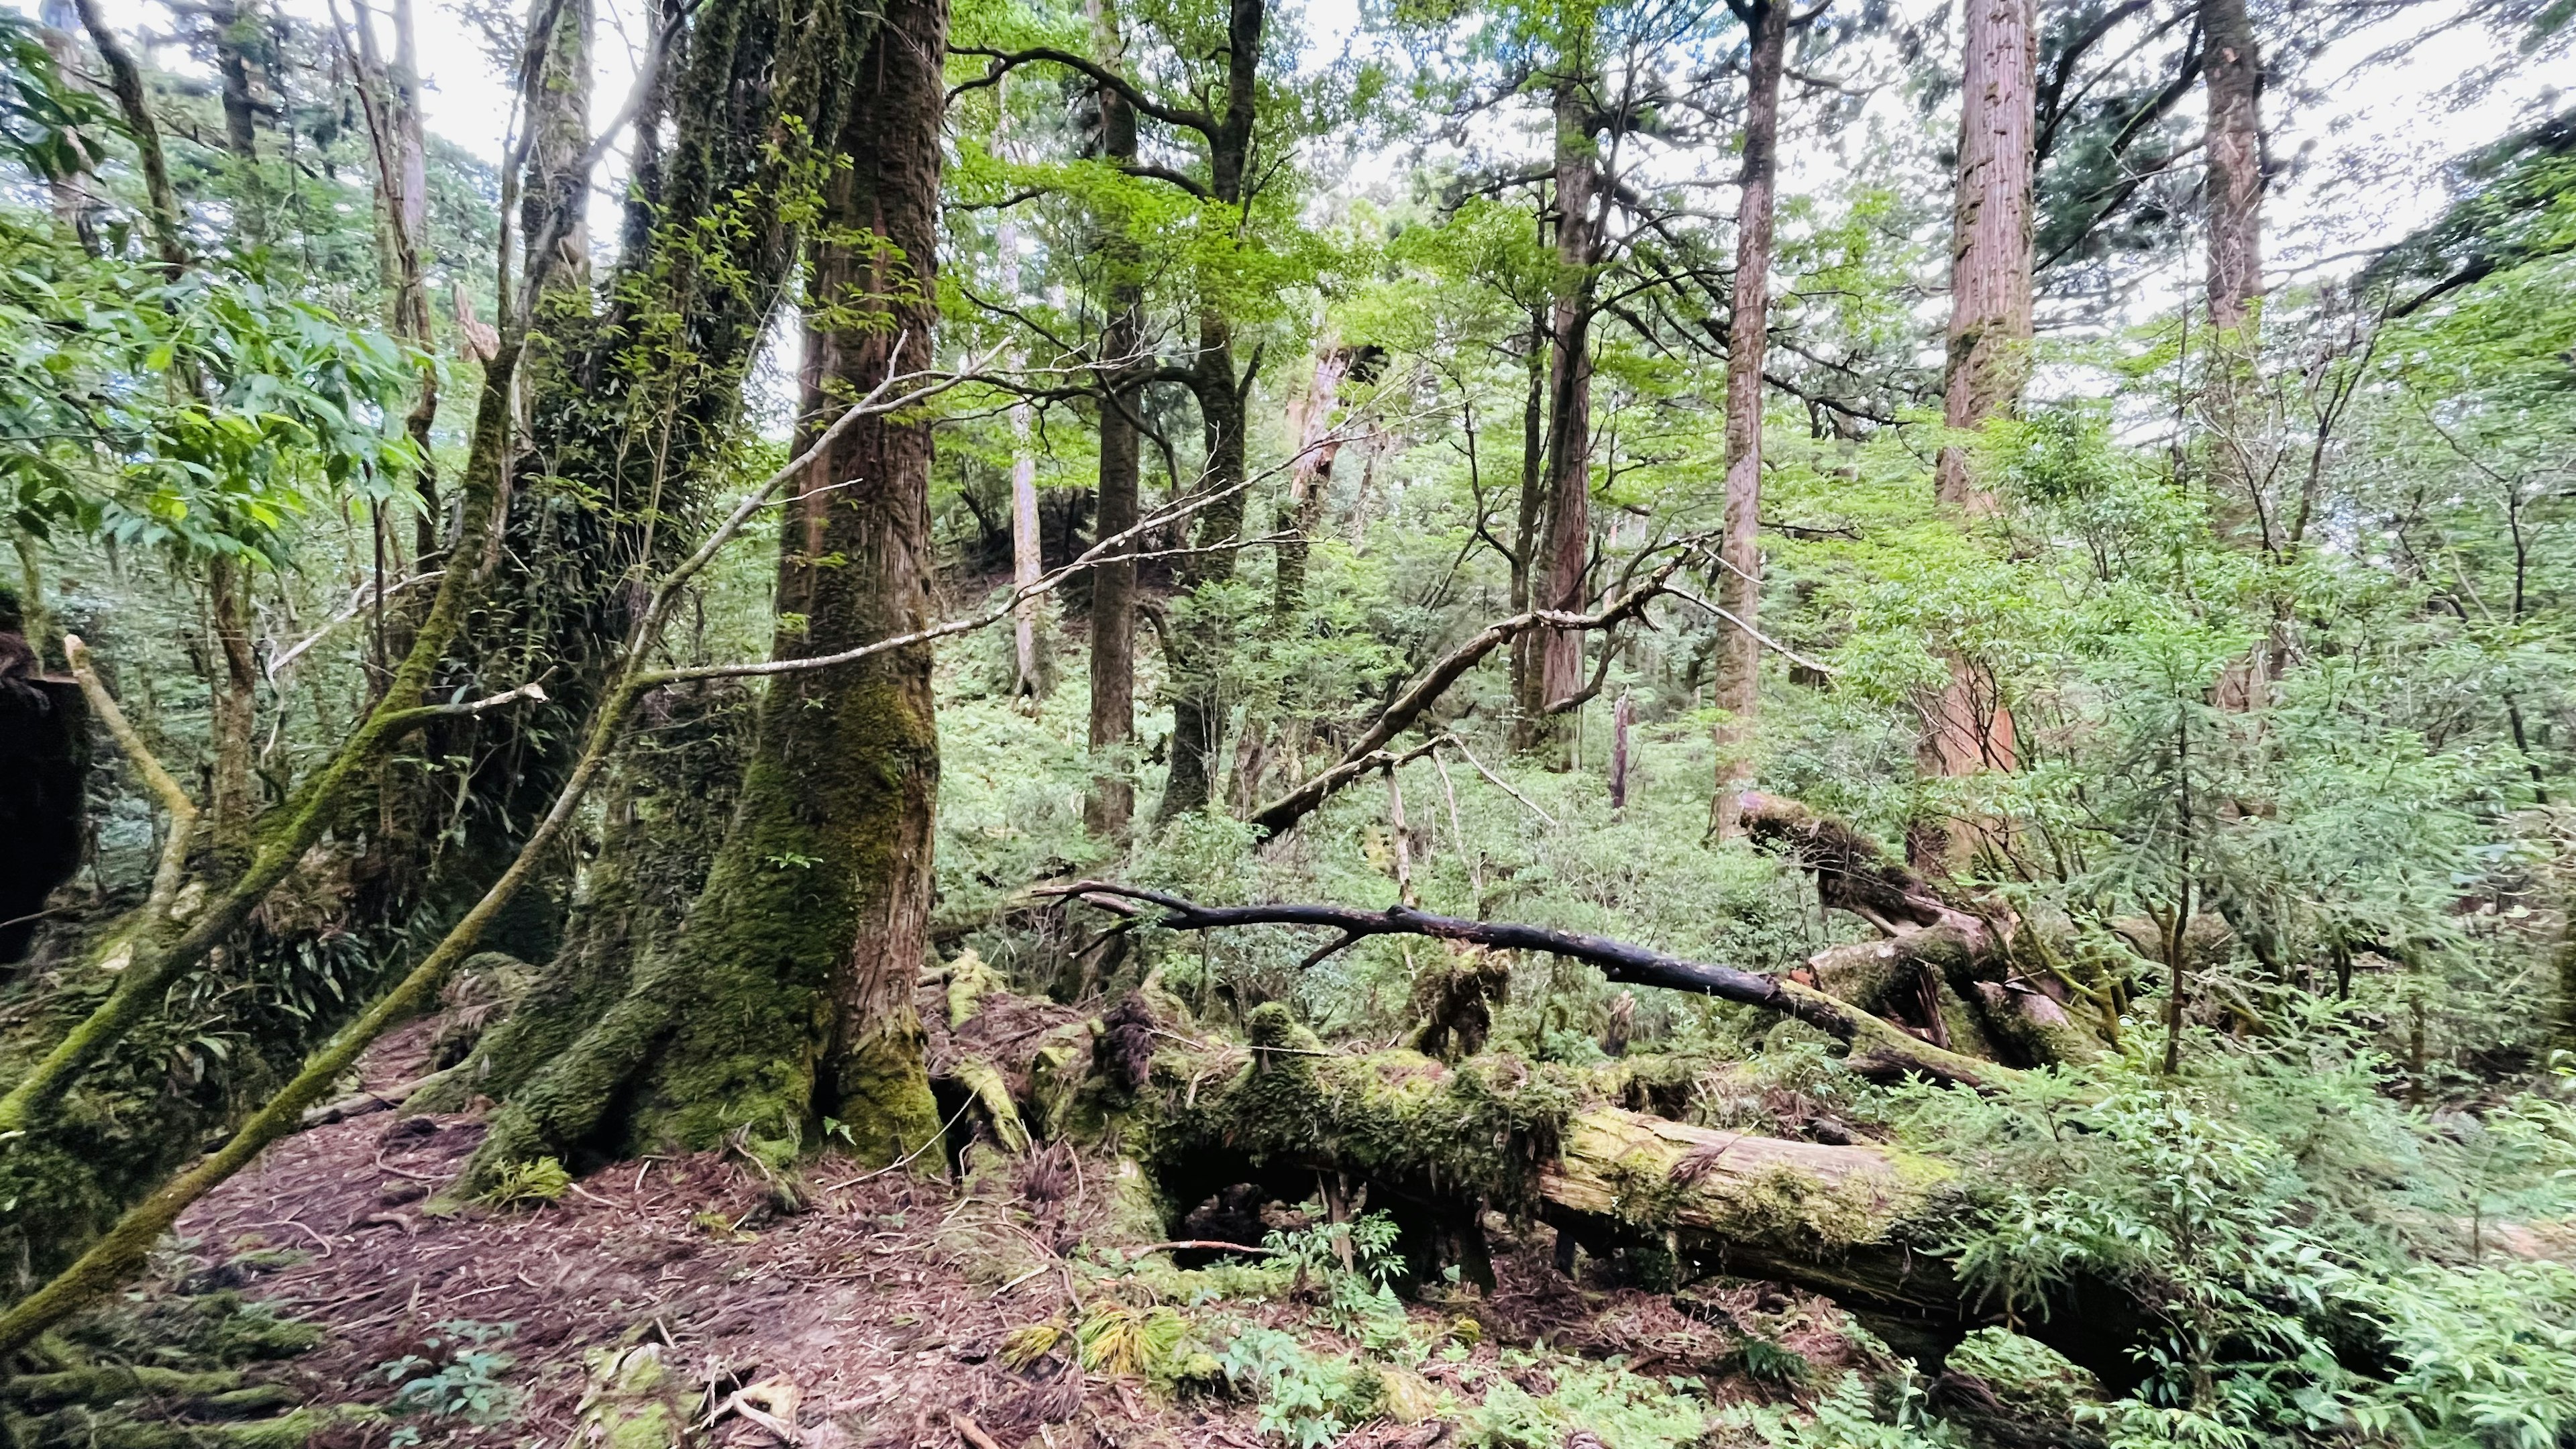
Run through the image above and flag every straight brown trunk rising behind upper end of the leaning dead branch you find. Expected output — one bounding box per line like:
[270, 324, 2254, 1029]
[1536, 77, 1602, 743]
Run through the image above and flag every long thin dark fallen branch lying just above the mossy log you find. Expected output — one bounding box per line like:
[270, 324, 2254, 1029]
[1049, 881, 2012, 1088]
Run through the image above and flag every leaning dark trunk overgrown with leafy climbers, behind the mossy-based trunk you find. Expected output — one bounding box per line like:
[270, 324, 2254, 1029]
[455, 0, 873, 959]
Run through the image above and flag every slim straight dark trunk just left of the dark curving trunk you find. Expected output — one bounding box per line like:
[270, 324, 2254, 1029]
[1082, 0, 1144, 838]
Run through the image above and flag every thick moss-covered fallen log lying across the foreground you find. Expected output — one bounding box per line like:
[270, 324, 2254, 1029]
[1136, 1003, 2141, 1379]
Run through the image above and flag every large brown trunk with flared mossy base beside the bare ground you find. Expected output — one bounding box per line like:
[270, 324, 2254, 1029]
[466, 0, 948, 1186]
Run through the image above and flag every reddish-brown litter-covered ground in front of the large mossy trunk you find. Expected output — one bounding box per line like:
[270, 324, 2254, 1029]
[134, 1021, 1855, 1449]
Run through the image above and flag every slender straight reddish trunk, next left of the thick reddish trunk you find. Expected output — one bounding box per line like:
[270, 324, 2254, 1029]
[1711, 0, 1788, 841]
